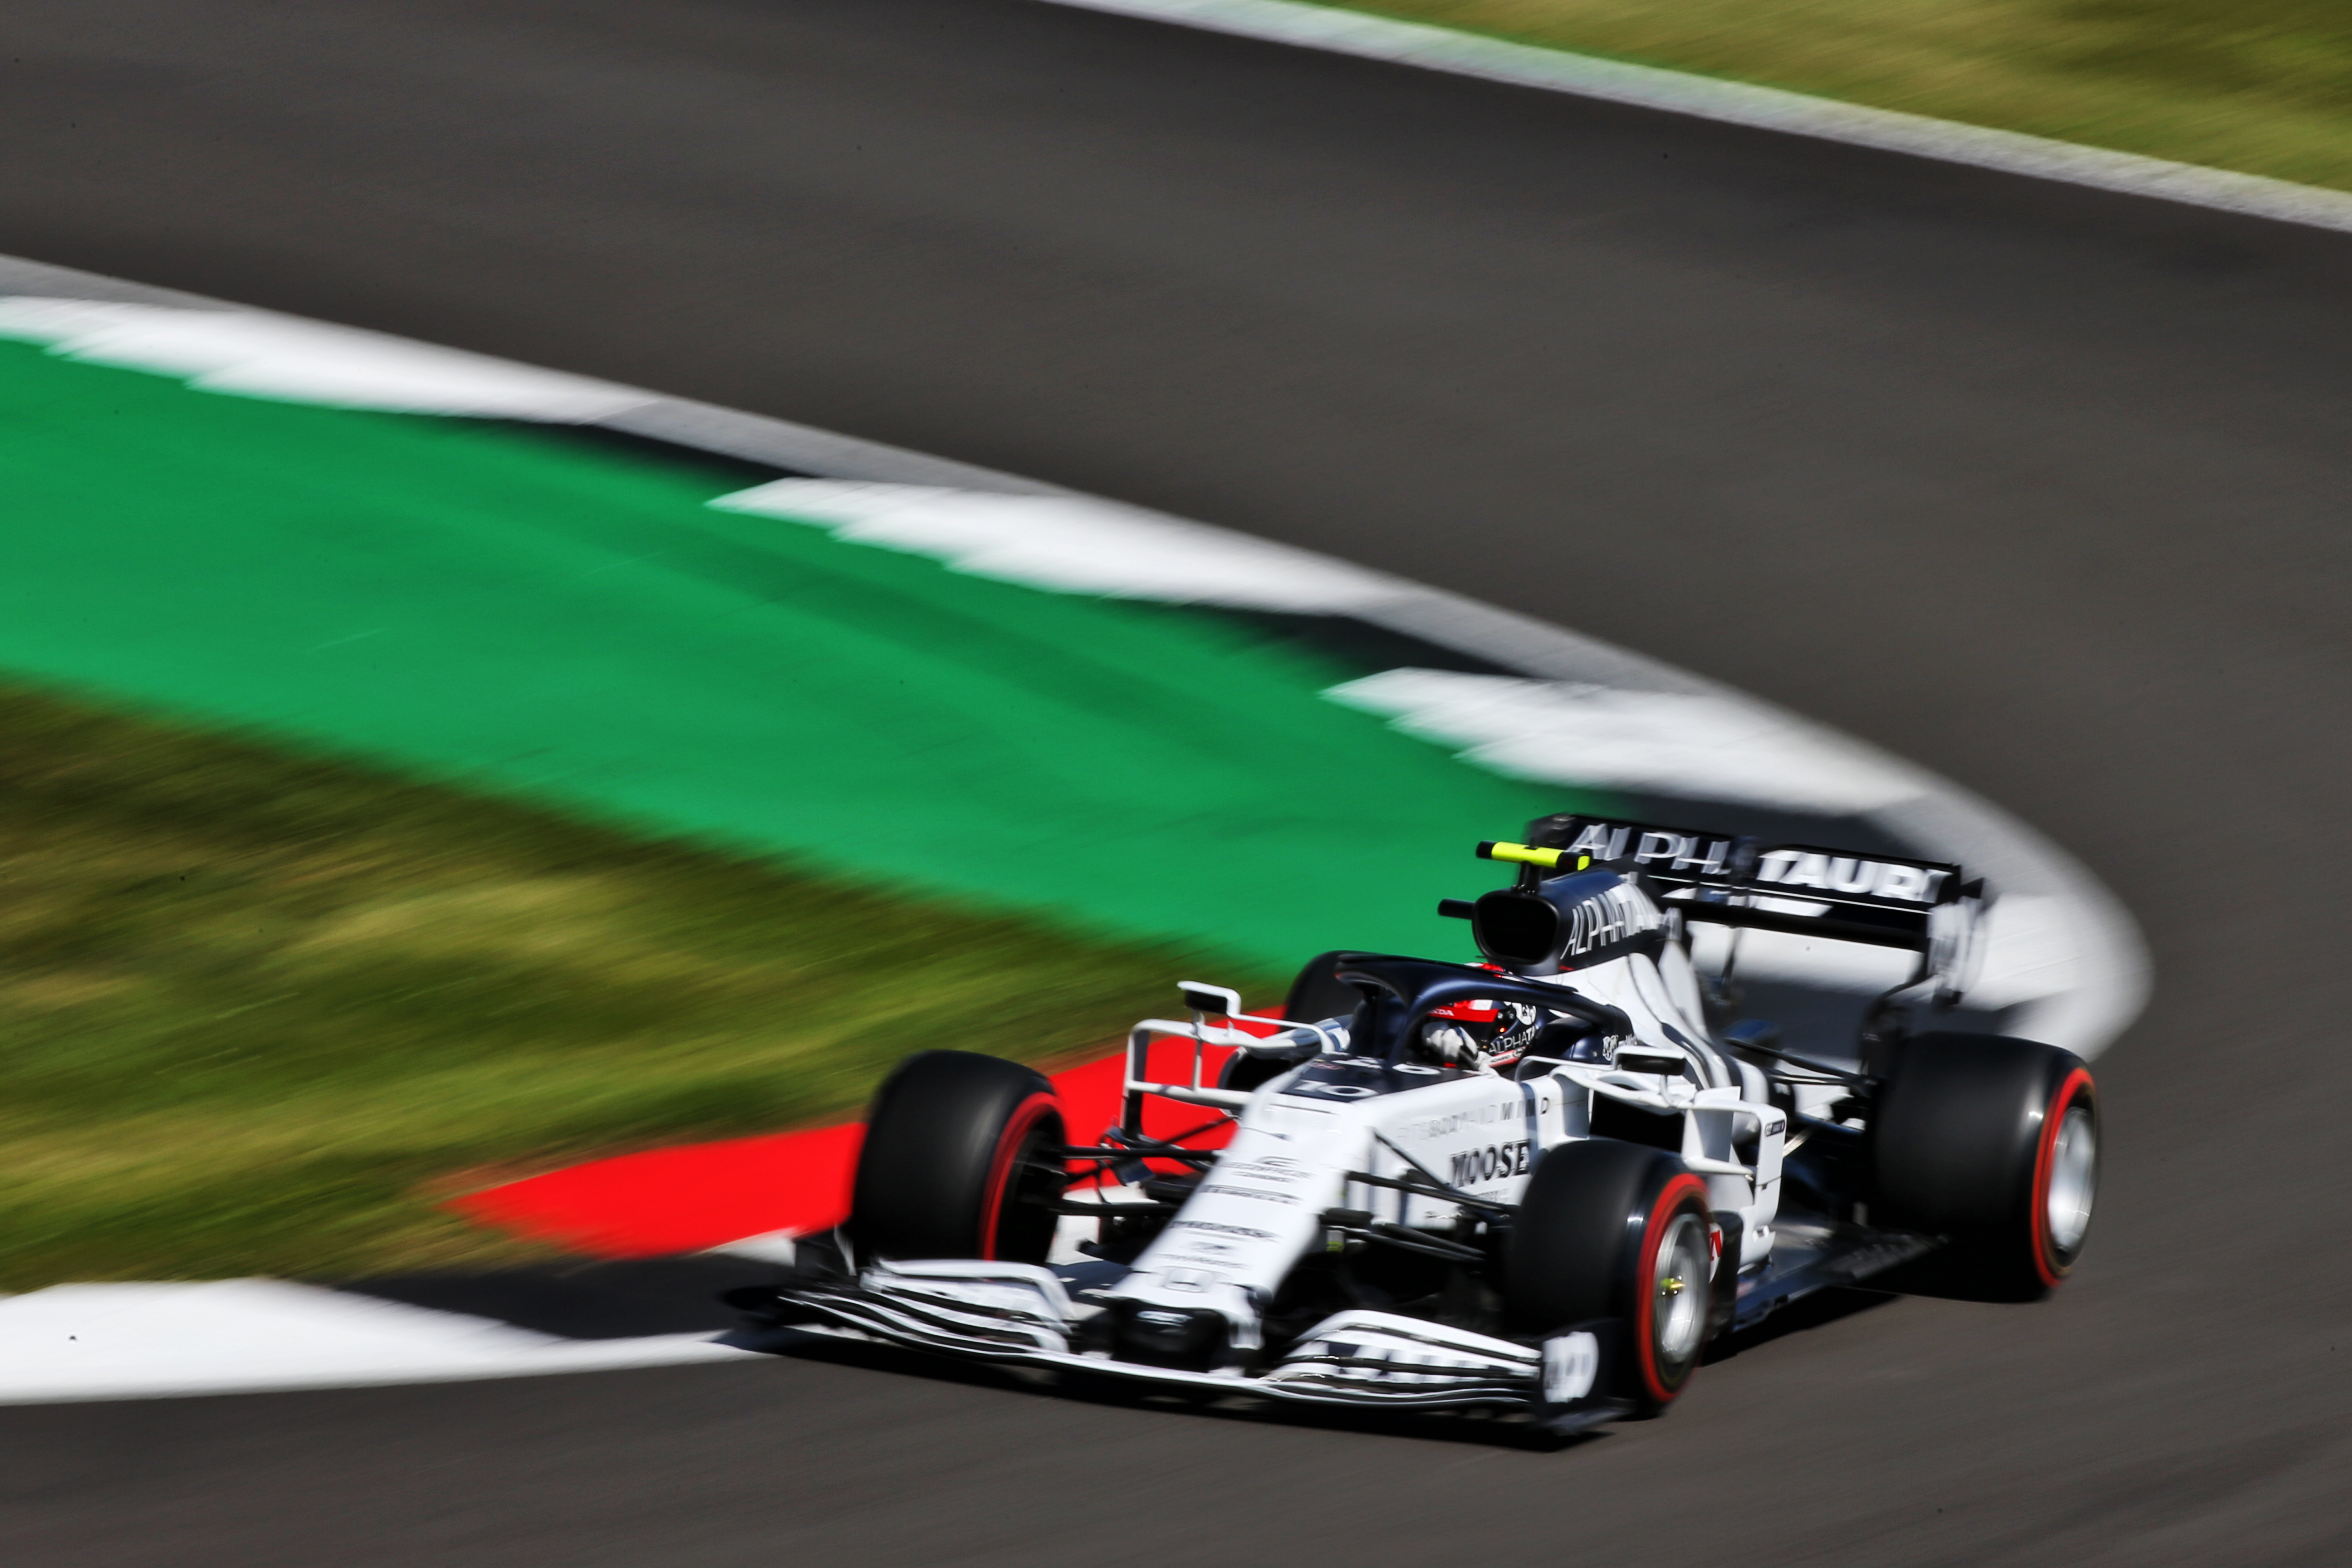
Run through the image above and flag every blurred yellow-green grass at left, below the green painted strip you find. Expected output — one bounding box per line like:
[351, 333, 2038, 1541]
[0, 686, 1279, 1288]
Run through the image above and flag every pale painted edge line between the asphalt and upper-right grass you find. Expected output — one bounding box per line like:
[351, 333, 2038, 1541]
[1047, 0, 2352, 230]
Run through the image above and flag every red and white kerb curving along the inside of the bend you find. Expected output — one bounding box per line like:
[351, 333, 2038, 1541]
[0, 263, 2145, 1403]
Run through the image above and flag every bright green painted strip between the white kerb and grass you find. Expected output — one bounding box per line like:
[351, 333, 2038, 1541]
[0, 343, 1607, 966]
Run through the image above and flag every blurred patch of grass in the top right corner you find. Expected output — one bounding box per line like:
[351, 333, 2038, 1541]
[1355, 0, 2352, 191]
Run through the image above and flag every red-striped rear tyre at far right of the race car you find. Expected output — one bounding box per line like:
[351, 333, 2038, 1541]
[1870, 1034, 2098, 1300]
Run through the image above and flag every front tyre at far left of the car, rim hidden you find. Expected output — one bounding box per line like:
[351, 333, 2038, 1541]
[849, 1051, 1068, 1262]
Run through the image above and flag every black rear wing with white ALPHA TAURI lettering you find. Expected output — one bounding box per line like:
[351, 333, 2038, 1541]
[1524, 816, 1985, 973]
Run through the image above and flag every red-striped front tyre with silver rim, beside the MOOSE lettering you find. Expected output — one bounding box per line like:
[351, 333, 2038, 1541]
[1503, 1138, 1715, 1415]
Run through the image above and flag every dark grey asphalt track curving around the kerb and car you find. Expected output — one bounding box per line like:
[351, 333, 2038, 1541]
[0, 0, 2352, 1566]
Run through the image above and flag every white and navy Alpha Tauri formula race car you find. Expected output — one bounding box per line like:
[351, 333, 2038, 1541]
[762, 816, 2098, 1431]
